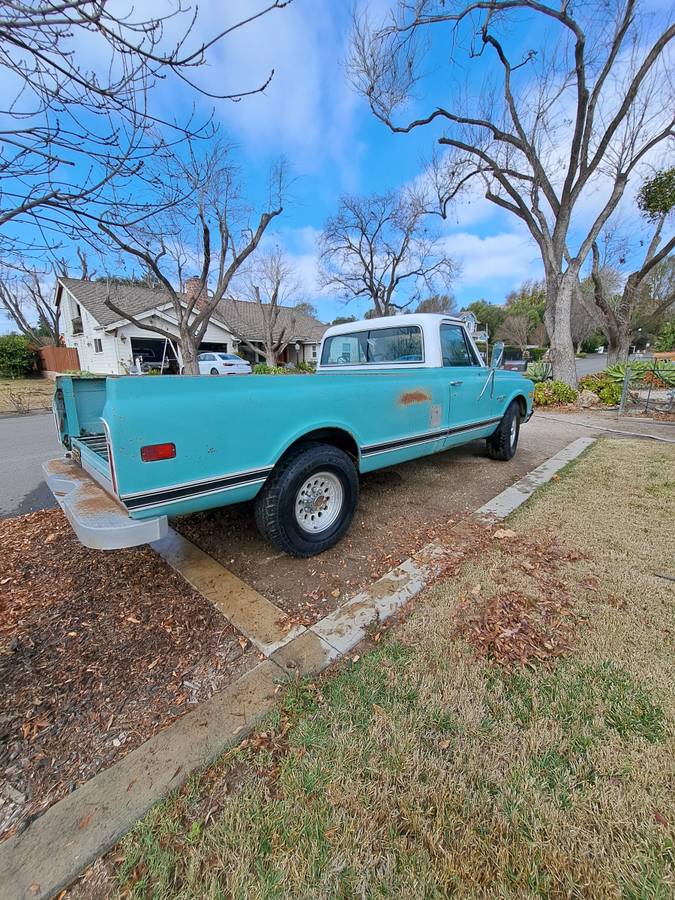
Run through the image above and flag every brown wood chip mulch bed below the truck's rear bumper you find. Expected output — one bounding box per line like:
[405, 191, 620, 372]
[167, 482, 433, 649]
[0, 510, 257, 840]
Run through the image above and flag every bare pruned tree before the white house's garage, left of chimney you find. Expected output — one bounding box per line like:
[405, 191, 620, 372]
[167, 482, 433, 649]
[99, 143, 284, 375]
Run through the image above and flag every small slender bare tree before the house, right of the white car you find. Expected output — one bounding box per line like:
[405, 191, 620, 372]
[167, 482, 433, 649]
[226, 247, 298, 367]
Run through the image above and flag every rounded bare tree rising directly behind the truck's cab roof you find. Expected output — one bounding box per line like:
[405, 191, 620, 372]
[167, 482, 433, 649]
[320, 191, 455, 316]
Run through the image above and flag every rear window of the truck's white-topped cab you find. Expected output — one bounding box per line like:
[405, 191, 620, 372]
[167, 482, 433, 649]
[321, 325, 424, 368]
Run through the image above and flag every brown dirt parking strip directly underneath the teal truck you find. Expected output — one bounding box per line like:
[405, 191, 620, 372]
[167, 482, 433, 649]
[177, 438, 556, 624]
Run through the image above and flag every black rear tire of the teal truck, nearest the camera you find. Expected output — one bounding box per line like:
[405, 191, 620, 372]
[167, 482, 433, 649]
[255, 441, 359, 558]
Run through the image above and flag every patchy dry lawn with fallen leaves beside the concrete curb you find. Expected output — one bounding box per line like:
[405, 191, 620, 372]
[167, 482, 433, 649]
[112, 440, 675, 900]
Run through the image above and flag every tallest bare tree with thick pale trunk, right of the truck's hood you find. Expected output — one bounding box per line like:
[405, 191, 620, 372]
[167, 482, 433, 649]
[351, 0, 675, 384]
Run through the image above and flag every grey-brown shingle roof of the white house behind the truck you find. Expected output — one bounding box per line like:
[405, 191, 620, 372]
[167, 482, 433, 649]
[59, 278, 328, 342]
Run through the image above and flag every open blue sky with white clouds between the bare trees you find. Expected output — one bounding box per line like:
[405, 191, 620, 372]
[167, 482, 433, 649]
[2, 0, 666, 332]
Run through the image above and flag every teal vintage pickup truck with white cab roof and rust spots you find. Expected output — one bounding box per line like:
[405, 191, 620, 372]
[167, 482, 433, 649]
[45, 315, 533, 557]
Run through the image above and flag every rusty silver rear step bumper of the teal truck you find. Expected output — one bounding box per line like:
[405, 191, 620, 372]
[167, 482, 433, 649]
[42, 458, 168, 550]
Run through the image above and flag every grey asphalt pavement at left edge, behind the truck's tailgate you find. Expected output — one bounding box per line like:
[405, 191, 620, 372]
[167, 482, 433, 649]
[0, 413, 60, 518]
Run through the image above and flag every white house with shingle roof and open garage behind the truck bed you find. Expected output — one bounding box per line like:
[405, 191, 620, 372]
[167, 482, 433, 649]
[56, 278, 327, 375]
